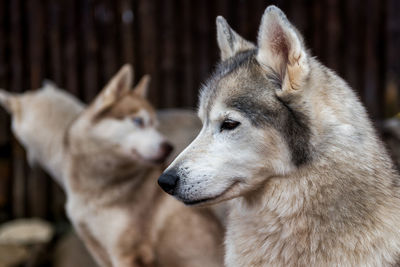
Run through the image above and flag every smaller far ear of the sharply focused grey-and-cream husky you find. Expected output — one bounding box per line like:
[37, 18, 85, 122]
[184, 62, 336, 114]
[216, 16, 255, 60]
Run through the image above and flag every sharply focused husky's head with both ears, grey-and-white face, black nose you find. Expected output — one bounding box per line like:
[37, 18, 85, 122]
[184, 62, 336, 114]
[158, 6, 318, 204]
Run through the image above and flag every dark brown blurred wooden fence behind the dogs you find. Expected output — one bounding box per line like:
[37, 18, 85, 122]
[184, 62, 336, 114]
[0, 0, 400, 221]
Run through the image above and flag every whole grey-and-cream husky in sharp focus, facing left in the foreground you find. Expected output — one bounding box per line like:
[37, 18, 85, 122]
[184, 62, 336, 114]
[158, 6, 400, 266]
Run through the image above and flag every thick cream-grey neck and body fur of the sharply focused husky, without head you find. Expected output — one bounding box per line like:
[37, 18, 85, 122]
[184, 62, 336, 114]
[225, 58, 400, 266]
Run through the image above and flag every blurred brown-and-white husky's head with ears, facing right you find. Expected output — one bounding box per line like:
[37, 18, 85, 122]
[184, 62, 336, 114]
[67, 65, 172, 168]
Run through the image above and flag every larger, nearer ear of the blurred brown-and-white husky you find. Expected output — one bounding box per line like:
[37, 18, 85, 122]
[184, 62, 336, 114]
[88, 64, 133, 115]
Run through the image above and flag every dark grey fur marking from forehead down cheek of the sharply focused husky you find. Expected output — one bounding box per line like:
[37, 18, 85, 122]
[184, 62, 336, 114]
[202, 49, 311, 166]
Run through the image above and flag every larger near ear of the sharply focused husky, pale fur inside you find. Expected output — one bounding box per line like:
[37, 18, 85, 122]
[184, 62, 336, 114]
[257, 6, 310, 94]
